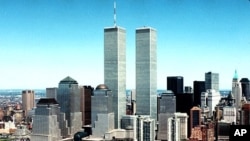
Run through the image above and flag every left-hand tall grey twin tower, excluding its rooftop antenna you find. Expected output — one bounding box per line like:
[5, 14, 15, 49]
[104, 26, 126, 128]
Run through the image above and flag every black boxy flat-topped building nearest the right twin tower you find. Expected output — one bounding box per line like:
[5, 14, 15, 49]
[167, 76, 184, 95]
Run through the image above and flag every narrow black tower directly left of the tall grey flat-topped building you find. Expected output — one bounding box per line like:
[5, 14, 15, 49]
[193, 81, 206, 106]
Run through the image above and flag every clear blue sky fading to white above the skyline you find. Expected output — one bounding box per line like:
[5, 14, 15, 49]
[0, 0, 250, 89]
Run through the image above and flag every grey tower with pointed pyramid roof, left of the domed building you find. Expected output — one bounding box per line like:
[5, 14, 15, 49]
[56, 76, 82, 137]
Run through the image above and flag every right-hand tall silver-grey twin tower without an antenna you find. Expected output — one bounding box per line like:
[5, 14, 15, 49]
[136, 27, 157, 119]
